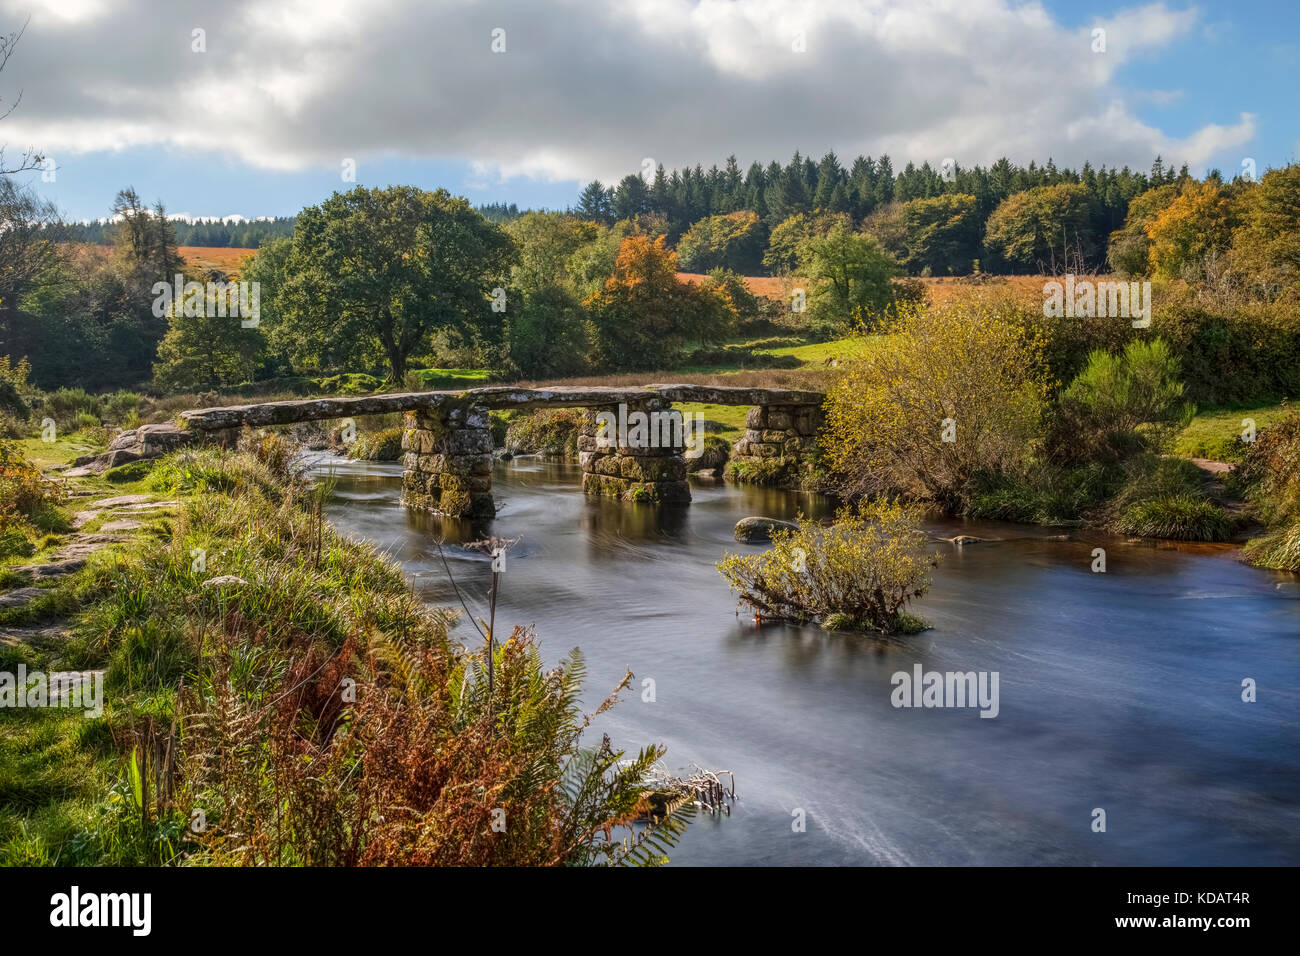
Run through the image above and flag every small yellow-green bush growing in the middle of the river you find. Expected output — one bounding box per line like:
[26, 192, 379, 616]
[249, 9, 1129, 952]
[718, 501, 935, 632]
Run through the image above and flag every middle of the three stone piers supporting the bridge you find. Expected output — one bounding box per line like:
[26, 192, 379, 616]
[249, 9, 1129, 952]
[577, 398, 690, 502]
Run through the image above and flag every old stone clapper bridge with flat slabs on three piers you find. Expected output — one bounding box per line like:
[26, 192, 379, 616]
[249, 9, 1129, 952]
[175, 385, 826, 518]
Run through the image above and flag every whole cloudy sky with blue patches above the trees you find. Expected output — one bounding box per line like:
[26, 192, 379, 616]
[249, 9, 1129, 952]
[0, 0, 1300, 220]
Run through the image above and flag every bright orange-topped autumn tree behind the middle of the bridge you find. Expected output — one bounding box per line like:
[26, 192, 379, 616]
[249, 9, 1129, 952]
[585, 235, 736, 371]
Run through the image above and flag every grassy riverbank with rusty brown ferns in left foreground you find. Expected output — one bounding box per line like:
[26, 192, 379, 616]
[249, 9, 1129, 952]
[0, 436, 702, 865]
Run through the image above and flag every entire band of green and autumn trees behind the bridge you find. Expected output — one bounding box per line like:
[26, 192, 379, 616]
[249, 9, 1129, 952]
[0, 160, 1300, 390]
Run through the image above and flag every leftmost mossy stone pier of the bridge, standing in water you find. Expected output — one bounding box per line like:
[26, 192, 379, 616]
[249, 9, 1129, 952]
[402, 403, 497, 518]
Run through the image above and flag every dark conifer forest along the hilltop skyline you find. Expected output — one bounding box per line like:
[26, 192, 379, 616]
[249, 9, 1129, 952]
[573, 152, 1196, 274]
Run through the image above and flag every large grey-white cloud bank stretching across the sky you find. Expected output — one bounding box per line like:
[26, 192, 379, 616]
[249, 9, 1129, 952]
[0, 0, 1255, 183]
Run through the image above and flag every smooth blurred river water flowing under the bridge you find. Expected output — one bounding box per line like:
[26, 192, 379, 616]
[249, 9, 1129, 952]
[319, 458, 1300, 865]
